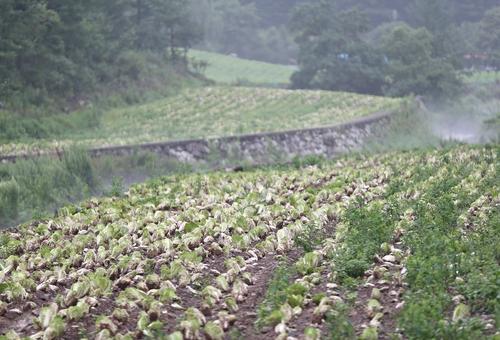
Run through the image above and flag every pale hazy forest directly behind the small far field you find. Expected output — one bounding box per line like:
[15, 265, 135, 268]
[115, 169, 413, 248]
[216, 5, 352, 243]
[193, 0, 296, 64]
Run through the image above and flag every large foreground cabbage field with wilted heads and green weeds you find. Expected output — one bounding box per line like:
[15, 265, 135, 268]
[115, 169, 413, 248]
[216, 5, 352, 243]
[0, 146, 500, 339]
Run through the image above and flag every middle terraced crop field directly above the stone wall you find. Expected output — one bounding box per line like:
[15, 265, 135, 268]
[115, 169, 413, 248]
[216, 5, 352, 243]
[0, 87, 401, 155]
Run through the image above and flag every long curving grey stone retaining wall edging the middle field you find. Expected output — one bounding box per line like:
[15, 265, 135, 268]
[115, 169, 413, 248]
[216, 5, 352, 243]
[0, 112, 391, 163]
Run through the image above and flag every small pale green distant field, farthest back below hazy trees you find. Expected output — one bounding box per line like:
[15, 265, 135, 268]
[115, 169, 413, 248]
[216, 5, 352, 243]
[189, 50, 296, 85]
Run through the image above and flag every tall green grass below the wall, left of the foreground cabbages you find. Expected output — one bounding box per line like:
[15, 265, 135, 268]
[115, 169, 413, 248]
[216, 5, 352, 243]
[0, 148, 198, 227]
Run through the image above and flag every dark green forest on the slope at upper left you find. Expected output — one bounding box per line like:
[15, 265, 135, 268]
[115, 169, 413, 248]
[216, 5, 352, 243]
[0, 0, 200, 108]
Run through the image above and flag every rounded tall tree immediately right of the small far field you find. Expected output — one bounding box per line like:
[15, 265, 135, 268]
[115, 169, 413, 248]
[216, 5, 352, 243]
[291, 1, 384, 94]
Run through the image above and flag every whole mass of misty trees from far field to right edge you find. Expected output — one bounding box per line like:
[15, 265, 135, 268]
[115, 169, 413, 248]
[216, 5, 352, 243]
[290, 0, 500, 97]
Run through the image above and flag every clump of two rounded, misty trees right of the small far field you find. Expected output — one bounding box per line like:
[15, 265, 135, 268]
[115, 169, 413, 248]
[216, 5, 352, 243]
[291, 2, 468, 97]
